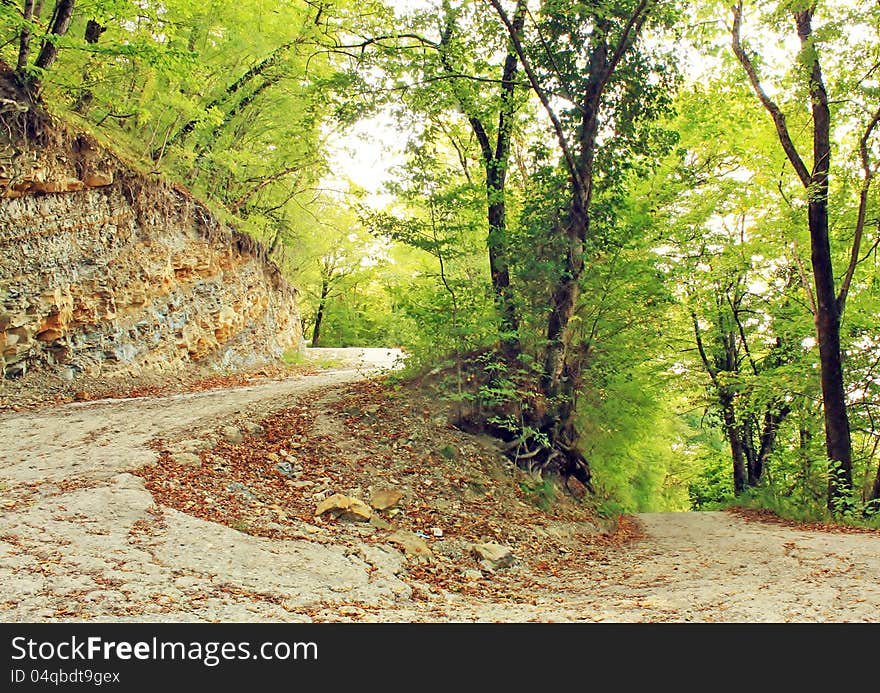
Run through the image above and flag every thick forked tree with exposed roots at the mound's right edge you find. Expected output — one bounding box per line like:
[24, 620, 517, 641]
[489, 0, 671, 483]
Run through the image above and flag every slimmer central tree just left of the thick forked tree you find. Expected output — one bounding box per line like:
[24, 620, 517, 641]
[326, 0, 527, 359]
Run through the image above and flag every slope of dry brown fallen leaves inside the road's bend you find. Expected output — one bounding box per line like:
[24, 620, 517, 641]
[137, 381, 641, 602]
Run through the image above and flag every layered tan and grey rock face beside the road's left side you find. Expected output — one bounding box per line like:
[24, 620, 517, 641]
[0, 75, 302, 379]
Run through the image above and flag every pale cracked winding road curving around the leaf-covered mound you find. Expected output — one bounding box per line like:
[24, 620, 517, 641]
[0, 350, 880, 622]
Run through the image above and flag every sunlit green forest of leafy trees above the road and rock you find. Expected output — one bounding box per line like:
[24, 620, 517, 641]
[0, 0, 880, 525]
